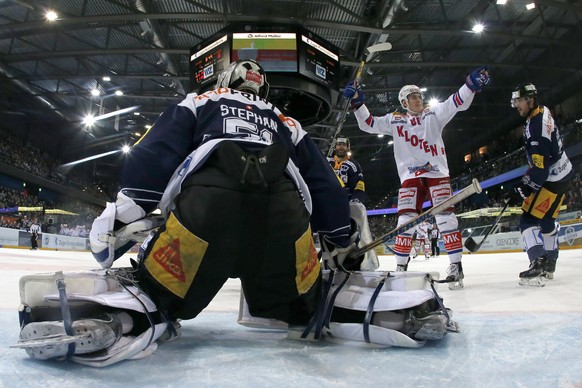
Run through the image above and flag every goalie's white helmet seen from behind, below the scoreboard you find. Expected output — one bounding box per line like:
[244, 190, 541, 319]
[216, 59, 269, 98]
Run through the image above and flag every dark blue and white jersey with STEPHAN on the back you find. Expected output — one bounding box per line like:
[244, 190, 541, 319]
[121, 88, 350, 246]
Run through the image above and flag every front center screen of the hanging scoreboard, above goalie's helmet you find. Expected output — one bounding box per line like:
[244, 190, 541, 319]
[232, 32, 297, 72]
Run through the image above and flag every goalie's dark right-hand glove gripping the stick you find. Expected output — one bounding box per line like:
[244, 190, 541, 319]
[321, 219, 365, 271]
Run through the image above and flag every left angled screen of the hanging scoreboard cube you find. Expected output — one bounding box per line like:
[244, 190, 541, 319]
[190, 35, 230, 90]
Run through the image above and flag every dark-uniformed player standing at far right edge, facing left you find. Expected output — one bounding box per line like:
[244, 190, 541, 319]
[509, 83, 574, 286]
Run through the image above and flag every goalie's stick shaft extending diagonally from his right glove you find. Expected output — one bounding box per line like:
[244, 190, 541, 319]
[346, 179, 482, 260]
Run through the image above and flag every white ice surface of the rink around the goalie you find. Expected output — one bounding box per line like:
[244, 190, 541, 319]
[0, 248, 582, 388]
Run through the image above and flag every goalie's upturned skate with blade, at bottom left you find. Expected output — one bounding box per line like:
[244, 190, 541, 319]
[12, 313, 131, 360]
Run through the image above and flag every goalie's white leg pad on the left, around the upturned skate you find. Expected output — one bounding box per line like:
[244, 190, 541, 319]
[16, 269, 168, 367]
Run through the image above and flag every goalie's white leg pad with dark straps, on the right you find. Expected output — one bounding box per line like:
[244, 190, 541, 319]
[322, 271, 456, 348]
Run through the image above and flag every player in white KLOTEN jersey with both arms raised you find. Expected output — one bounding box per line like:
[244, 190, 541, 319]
[344, 66, 491, 288]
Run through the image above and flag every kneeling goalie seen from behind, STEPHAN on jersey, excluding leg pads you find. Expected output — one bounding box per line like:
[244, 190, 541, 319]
[92, 60, 355, 324]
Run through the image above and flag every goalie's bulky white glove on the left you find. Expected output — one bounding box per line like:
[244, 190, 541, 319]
[89, 191, 163, 268]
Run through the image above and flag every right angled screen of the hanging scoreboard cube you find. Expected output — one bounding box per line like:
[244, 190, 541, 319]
[299, 35, 340, 89]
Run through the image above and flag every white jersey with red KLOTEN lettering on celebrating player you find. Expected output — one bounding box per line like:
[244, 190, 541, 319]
[354, 85, 474, 183]
